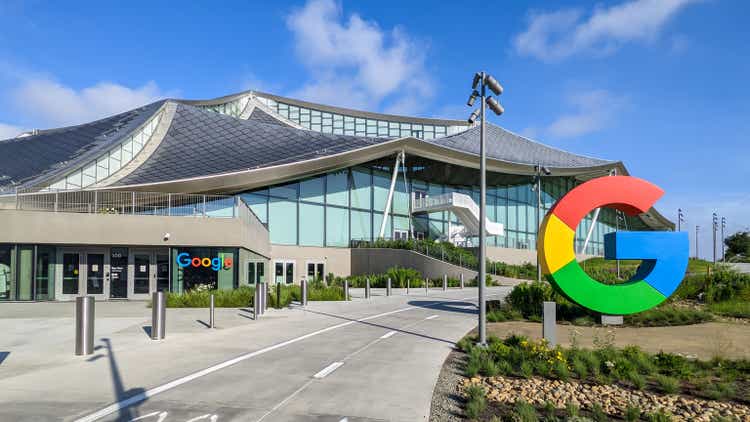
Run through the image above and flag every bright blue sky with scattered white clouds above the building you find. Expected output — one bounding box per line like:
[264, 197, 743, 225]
[0, 0, 750, 258]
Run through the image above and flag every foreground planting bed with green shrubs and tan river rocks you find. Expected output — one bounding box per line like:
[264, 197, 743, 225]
[449, 335, 750, 421]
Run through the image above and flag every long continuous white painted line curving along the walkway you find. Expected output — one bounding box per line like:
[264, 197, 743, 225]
[76, 297, 494, 422]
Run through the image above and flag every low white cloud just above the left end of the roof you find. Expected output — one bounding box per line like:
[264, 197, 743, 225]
[12, 78, 165, 126]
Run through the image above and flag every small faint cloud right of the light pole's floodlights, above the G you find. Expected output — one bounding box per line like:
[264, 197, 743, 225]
[543, 89, 626, 138]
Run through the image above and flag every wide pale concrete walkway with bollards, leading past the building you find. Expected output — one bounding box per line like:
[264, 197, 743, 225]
[0, 288, 509, 422]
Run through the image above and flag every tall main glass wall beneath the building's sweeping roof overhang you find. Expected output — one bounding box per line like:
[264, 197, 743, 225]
[240, 160, 645, 255]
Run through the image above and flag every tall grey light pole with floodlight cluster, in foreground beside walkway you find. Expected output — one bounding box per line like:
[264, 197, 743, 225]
[466, 72, 504, 346]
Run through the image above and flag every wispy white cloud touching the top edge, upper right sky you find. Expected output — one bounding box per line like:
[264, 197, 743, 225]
[514, 0, 700, 61]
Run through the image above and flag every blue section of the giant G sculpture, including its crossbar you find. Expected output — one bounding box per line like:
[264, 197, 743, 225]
[604, 232, 690, 297]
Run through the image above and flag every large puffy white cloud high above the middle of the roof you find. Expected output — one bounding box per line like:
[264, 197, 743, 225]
[287, 0, 432, 113]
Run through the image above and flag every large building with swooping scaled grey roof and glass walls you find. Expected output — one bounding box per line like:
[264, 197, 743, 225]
[0, 91, 673, 300]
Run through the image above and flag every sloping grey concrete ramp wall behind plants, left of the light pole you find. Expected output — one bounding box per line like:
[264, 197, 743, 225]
[351, 248, 477, 282]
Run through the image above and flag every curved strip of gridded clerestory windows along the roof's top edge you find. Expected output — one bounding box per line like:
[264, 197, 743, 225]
[258, 97, 469, 139]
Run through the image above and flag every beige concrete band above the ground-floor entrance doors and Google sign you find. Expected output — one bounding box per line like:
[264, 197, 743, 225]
[0, 210, 271, 256]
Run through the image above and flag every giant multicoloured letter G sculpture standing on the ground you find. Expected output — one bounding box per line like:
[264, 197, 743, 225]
[537, 176, 689, 315]
